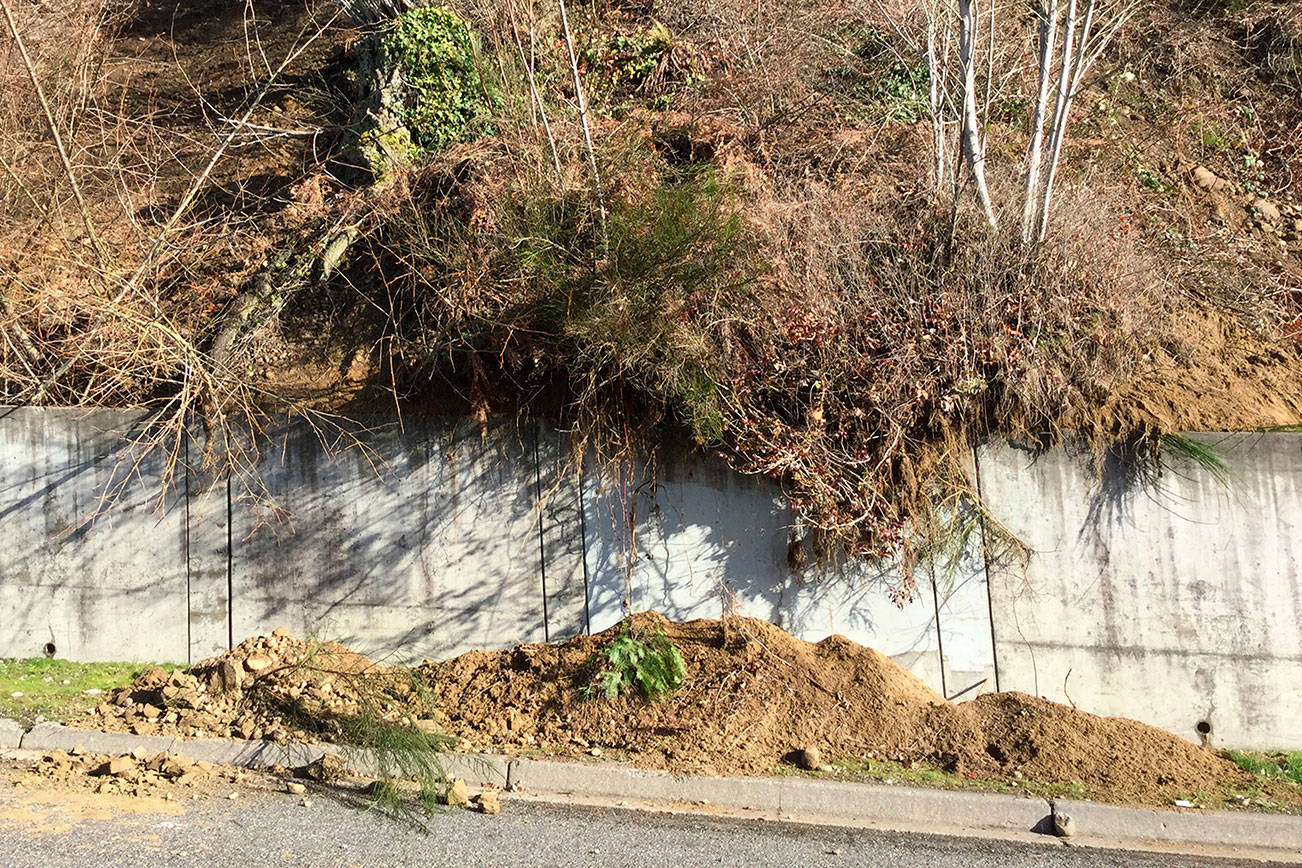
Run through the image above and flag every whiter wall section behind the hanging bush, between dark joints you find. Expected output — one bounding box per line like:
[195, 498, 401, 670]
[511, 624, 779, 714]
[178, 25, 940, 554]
[583, 450, 993, 694]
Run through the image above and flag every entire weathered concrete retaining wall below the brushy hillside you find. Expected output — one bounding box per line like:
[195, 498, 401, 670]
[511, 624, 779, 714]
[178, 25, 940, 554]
[0, 409, 1302, 747]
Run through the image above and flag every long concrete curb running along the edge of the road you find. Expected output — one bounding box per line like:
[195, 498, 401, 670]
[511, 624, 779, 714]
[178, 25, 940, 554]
[10, 720, 1302, 861]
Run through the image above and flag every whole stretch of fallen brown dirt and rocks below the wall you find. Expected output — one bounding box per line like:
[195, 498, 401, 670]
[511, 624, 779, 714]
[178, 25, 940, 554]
[73, 613, 1302, 811]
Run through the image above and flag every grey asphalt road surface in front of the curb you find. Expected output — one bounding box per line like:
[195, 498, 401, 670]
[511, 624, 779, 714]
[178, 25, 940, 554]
[0, 789, 1281, 868]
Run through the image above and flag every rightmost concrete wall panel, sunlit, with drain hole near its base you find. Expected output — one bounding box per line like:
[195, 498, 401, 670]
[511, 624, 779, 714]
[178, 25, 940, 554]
[979, 433, 1302, 748]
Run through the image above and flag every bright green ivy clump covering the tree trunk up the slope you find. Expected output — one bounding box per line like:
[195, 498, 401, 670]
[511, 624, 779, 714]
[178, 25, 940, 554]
[384, 7, 496, 151]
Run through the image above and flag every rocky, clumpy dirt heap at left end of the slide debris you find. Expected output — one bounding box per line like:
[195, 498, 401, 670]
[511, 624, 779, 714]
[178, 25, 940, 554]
[73, 630, 426, 742]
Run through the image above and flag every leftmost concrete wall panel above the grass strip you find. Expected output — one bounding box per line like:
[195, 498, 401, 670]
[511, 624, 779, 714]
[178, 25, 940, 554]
[0, 409, 189, 661]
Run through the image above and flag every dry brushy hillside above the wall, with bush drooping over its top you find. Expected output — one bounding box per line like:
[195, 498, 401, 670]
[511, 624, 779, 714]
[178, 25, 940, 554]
[0, 0, 1302, 588]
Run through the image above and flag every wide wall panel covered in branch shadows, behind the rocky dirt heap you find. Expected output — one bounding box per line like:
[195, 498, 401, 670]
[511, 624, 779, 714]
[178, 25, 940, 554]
[232, 419, 544, 662]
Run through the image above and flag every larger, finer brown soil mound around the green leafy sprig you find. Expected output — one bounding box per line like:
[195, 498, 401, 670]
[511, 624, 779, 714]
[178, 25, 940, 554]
[421, 613, 1242, 803]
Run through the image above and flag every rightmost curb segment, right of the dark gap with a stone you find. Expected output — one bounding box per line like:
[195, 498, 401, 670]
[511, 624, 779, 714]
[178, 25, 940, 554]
[1053, 799, 1302, 856]
